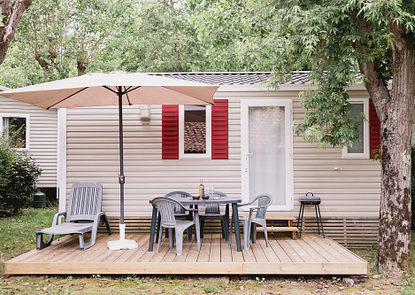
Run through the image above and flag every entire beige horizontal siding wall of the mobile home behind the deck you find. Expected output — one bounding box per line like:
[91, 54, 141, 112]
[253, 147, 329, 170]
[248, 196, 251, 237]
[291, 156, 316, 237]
[67, 91, 380, 218]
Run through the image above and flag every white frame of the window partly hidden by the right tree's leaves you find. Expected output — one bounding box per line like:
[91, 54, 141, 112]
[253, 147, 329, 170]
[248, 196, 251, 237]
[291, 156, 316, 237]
[342, 98, 370, 159]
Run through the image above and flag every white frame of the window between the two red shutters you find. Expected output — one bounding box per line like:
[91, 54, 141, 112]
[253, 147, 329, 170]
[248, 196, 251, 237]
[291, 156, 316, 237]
[179, 105, 212, 159]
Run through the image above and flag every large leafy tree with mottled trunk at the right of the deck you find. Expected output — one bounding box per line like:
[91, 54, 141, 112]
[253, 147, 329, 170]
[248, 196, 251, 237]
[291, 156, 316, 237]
[194, 0, 415, 277]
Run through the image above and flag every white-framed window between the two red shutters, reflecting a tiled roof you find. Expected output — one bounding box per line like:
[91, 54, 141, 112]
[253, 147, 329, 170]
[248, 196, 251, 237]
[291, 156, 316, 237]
[179, 105, 212, 159]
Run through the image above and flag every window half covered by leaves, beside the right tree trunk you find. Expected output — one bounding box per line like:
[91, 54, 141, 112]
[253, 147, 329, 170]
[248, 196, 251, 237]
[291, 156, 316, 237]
[342, 99, 370, 159]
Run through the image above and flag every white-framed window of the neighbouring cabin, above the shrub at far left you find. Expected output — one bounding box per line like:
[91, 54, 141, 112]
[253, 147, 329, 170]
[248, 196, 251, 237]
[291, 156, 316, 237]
[0, 114, 30, 149]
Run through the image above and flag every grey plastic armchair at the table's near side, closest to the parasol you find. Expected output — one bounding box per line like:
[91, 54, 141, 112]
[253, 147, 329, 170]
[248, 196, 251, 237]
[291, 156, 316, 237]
[152, 197, 200, 256]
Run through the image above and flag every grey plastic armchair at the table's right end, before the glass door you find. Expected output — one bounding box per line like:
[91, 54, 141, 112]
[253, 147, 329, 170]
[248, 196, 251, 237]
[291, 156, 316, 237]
[229, 194, 272, 250]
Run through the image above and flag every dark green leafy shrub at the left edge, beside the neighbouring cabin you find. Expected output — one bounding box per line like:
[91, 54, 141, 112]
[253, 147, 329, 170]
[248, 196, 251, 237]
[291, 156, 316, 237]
[0, 131, 41, 216]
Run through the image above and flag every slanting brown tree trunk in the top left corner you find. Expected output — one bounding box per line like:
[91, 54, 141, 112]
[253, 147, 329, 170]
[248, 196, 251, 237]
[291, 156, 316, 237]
[0, 0, 32, 64]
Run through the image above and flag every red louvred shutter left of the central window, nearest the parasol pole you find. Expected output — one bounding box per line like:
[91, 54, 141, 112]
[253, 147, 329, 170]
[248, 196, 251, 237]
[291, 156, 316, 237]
[161, 105, 179, 159]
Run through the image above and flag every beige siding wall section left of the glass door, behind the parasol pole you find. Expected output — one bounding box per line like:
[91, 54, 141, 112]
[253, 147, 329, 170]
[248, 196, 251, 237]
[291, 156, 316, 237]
[67, 100, 241, 216]
